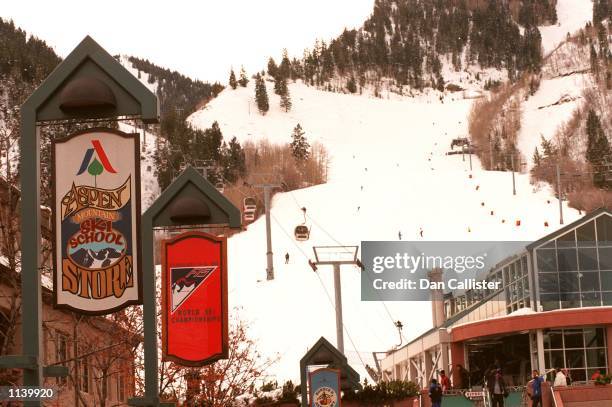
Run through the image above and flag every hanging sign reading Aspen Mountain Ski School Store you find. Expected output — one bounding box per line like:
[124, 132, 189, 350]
[52, 128, 142, 315]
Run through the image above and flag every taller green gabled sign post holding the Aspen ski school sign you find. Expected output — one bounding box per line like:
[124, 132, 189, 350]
[0, 37, 159, 406]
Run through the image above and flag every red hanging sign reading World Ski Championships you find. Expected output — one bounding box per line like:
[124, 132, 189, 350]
[162, 231, 228, 366]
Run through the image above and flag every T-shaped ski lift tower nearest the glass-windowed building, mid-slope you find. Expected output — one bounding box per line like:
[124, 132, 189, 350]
[311, 246, 362, 354]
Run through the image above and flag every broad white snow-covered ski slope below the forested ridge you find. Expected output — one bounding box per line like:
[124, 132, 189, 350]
[190, 83, 578, 380]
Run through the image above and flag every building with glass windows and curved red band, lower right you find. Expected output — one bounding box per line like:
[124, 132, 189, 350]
[380, 209, 612, 394]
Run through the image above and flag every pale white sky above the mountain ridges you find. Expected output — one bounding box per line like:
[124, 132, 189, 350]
[0, 0, 374, 83]
